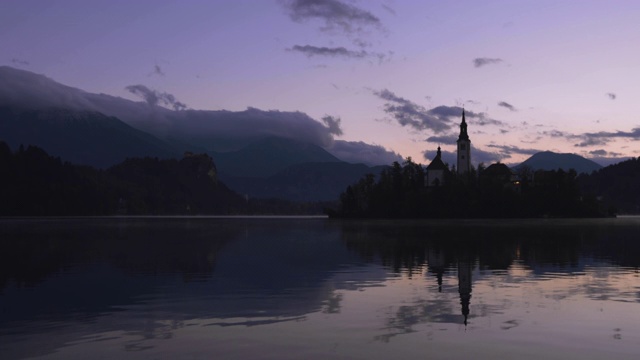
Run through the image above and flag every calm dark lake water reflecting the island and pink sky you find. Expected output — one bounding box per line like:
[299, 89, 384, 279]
[0, 217, 640, 359]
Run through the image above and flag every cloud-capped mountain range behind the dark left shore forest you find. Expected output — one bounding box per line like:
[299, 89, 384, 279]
[0, 66, 402, 201]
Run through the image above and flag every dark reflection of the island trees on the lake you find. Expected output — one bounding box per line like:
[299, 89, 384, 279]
[342, 219, 640, 277]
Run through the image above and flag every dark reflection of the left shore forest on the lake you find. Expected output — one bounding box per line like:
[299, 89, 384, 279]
[0, 219, 241, 288]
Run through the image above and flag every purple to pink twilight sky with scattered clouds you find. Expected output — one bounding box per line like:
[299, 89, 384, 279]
[0, 0, 640, 164]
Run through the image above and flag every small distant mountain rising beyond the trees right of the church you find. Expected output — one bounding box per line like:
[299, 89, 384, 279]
[515, 151, 602, 174]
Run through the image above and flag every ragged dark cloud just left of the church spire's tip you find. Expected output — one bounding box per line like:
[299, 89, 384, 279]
[373, 89, 462, 133]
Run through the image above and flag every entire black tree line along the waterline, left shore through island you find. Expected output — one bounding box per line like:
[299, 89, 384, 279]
[0, 142, 640, 218]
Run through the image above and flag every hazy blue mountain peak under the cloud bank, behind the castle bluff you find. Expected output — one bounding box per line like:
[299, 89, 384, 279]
[210, 137, 341, 178]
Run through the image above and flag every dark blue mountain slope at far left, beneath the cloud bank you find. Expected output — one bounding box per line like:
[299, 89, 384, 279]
[0, 106, 180, 168]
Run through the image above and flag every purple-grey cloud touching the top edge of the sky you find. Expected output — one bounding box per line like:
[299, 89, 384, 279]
[283, 0, 382, 34]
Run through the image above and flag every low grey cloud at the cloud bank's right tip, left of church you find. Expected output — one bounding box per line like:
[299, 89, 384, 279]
[326, 140, 403, 166]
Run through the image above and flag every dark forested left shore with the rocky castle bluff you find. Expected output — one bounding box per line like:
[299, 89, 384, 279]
[0, 142, 327, 216]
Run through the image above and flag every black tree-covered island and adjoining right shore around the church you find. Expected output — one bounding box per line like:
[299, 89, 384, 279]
[329, 158, 640, 218]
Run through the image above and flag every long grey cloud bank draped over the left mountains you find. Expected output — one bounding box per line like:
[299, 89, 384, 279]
[0, 66, 402, 165]
